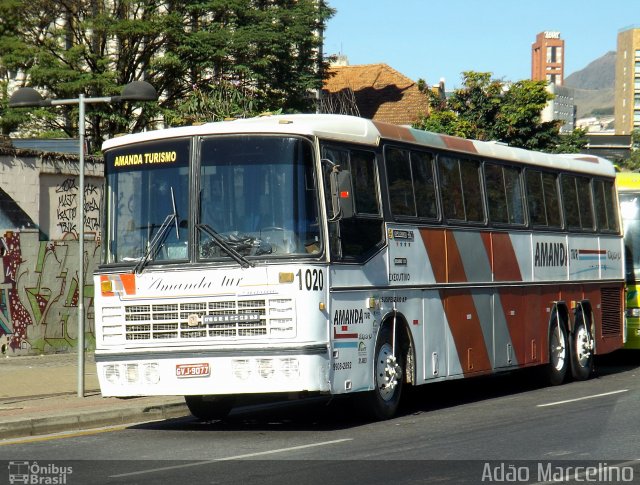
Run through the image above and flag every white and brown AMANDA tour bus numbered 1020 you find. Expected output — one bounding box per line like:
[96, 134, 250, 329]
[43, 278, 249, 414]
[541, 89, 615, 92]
[95, 115, 624, 419]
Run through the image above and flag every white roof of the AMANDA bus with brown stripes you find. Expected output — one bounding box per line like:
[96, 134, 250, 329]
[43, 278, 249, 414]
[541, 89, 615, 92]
[102, 114, 615, 177]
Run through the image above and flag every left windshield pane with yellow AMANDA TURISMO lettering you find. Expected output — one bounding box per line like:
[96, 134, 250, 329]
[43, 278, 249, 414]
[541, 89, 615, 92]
[105, 139, 190, 264]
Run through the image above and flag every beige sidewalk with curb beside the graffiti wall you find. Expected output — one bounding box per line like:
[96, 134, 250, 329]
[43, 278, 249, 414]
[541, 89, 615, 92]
[0, 353, 189, 444]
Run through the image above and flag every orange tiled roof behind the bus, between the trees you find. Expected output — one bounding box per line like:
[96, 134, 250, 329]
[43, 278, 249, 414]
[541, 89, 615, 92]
[324, 64, 428, 125]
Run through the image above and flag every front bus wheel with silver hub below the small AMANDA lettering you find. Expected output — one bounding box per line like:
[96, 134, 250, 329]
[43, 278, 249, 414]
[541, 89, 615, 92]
[365, 325, 404, 420]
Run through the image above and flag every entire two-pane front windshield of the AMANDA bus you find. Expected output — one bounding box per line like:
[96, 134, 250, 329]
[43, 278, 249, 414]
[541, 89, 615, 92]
[105, 135, 321, 264]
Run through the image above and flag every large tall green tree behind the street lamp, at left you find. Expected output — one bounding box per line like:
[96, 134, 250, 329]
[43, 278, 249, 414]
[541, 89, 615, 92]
[0, 0, 333, 148]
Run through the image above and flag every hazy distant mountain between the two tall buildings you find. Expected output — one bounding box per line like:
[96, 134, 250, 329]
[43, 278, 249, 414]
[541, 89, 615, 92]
[564, 51, 616, 118]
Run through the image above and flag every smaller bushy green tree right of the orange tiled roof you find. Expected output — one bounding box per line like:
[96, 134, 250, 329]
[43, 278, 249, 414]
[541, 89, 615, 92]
[415, 71, 586, 152]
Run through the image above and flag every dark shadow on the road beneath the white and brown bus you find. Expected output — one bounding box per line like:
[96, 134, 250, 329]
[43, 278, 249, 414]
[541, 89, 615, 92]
[130, 350, 640, 432]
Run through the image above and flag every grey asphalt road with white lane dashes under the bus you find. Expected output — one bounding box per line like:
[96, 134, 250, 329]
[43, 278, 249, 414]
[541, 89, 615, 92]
[0, 352, 640, 485]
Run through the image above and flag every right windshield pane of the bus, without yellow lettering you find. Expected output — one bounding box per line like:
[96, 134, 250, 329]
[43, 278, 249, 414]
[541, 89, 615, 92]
[197, 135, 320, 260]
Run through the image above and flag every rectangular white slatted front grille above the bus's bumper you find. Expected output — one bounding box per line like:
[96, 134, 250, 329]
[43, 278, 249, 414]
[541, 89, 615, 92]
[124, 298, 295, 342]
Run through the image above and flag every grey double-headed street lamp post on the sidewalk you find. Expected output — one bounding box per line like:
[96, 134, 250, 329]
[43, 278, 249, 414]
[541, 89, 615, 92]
[9, 81, 158, 397]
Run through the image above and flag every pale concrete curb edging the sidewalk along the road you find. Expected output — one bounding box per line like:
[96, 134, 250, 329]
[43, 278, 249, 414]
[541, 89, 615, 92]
[0, 403, 190, 439]
